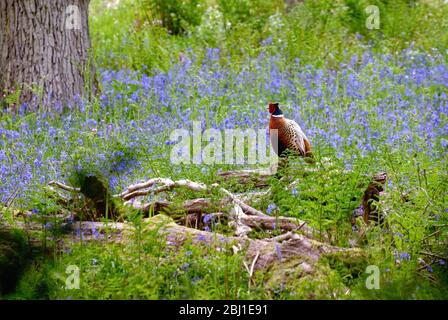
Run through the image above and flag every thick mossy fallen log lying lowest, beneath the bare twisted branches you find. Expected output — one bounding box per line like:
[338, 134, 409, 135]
[144, 214, 367, 288]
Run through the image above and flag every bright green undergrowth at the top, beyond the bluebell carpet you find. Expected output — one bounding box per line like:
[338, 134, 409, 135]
[90, 0, 448, 73]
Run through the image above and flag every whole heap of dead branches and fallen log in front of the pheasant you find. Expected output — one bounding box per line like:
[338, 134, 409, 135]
[40, 170, 362, 274]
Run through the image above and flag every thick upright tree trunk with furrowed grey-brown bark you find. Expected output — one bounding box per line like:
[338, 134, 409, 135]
[0, 0, 96, 111]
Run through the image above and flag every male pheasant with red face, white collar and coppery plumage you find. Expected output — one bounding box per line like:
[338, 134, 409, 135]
[269, 103, 312, 158]
